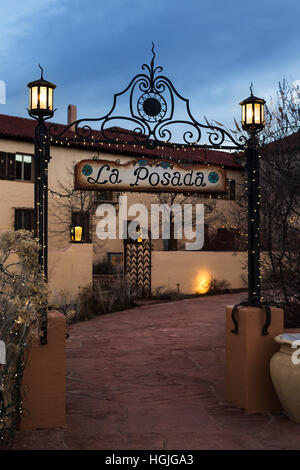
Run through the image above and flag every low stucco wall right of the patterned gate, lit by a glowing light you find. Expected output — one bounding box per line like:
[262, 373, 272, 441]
[151, 251, 246, 294]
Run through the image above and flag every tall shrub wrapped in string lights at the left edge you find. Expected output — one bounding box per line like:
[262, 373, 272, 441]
[0, 230, 47, 444]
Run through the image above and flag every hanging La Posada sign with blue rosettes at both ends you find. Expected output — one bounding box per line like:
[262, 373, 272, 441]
[75, 159, 227, 193]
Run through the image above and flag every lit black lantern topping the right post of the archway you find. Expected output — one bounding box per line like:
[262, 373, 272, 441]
[240, 83, 266, 132]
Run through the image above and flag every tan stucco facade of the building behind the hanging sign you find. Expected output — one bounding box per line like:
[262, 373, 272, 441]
[0, 139, 243, 260]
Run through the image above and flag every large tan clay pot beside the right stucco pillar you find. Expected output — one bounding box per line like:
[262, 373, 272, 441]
[270, 333, 300, 423]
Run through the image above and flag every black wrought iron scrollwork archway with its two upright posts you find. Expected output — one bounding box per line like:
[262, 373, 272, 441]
[29, 45, 269, 343]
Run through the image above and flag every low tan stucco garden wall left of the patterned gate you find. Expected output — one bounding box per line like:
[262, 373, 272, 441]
[48, 243, 93, 302]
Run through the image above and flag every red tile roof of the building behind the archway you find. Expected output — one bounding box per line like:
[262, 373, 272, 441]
[0, 114, 242, 169]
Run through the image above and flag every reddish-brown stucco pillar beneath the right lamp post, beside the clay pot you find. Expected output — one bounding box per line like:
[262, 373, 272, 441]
[225, 306, 283, 413]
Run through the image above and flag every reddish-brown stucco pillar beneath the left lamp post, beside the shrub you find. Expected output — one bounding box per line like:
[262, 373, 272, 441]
[20, 311, 66, 430]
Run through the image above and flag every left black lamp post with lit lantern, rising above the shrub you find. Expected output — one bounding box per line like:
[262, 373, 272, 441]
[27, 66, 56, 344]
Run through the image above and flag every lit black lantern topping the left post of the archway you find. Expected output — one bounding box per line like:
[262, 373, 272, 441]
[27, 65, 56, 117]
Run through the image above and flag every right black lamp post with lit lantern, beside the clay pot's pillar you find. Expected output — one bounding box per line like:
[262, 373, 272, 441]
[240, 84, 265, 305]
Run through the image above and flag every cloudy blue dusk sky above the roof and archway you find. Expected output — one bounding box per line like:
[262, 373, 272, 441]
[0, 0, 300, 134]
